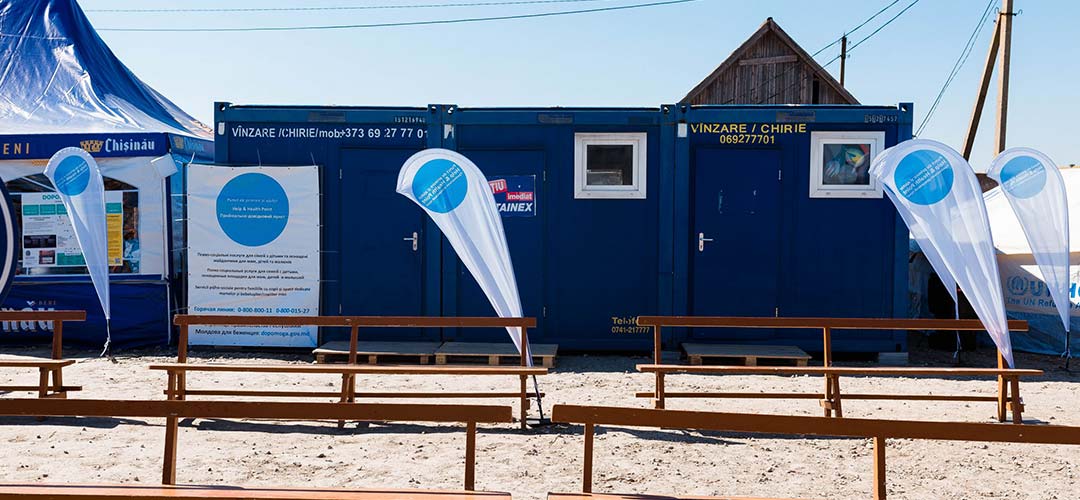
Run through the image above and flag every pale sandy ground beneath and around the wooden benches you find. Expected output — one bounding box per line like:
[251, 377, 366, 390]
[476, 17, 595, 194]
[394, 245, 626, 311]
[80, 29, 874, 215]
[0, 341, 1080, 500]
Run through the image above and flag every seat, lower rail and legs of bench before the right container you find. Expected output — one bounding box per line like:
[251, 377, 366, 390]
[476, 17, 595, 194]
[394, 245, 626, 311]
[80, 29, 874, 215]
[636, 364, 1043, 423]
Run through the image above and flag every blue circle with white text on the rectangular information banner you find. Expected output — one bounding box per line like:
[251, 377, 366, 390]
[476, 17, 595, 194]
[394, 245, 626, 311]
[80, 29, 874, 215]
[217, 173, 288, 246]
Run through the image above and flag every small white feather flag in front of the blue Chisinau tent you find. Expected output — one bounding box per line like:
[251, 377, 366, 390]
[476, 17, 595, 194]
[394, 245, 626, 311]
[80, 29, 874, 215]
[45, 148, 110, 350]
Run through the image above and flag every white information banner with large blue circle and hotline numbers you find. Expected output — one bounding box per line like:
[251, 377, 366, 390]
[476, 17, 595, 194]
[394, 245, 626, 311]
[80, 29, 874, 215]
[188, 165, 321, 347]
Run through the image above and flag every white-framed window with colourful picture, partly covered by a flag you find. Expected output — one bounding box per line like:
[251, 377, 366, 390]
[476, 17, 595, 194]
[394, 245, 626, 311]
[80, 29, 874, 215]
[810, 132, 885, 198]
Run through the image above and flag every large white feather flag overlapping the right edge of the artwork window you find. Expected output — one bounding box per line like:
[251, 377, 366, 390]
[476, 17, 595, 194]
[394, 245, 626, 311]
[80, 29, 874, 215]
[870, 139, 1015, 367]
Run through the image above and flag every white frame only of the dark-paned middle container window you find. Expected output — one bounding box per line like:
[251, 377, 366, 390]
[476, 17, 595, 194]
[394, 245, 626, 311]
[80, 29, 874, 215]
[573, 132, 649, 200]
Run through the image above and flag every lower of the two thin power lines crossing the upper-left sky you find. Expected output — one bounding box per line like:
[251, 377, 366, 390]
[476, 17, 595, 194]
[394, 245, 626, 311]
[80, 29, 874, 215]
[98, 0, 699, 32]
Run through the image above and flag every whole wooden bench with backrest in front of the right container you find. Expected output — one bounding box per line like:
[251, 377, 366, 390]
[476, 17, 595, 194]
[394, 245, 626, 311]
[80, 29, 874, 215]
[637, 316, 1042, 423]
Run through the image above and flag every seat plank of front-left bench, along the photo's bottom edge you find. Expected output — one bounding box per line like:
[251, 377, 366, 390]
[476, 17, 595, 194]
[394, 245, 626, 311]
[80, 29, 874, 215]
[0, 485, 511, 500]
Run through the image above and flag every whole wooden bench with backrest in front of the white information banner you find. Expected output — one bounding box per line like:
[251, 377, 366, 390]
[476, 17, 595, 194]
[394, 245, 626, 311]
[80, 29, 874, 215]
[173, 314, 546, 429]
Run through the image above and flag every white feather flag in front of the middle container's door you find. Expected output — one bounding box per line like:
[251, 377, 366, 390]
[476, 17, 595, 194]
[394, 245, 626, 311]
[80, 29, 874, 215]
[397, 148, 532, 366]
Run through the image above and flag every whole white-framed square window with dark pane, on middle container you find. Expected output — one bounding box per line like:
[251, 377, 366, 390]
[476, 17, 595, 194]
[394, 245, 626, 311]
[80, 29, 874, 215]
[573, 133, 647, 199]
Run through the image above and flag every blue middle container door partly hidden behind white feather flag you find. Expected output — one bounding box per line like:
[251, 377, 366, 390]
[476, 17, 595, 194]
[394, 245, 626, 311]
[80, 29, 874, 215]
[443, 150, 548, 342]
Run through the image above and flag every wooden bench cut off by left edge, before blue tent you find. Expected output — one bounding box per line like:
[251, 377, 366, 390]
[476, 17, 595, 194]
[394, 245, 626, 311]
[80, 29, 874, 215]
[0, 311, 86, 398]
